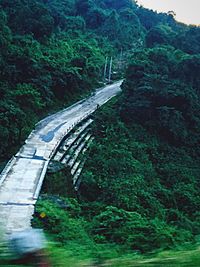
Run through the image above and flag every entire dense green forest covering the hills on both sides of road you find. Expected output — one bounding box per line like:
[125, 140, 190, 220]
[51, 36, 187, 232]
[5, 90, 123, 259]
[0, 0, 200, 266]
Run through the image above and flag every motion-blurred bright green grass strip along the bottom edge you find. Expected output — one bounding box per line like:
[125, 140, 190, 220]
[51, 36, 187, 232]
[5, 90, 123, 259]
[0, 233, 200, 267]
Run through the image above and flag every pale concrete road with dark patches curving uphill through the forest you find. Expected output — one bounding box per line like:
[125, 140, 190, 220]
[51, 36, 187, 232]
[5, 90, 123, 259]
[0, 81, 122, 233]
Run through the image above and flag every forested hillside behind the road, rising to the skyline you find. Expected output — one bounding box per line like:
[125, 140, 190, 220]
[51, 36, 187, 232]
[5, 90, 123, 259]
[0, 0, 200, 163]
